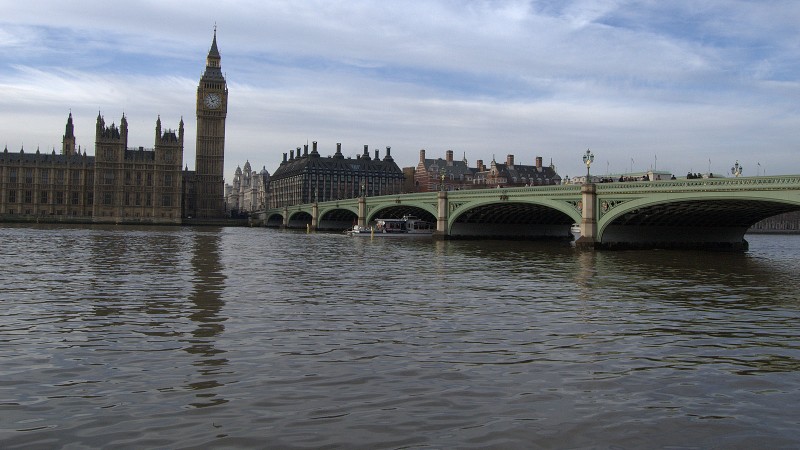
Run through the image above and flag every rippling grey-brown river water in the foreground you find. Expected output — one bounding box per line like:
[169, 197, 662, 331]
[0, 225, 800, 448]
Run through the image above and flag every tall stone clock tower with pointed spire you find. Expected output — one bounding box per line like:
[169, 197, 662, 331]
[195, 26, 228, 219]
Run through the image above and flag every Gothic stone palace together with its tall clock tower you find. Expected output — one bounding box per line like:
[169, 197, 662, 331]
[0, 30, 228, 224]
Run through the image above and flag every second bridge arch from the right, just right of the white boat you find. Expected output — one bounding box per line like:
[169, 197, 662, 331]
[447, 198, 581, 239]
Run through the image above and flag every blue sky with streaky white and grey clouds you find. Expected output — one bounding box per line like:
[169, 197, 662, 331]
[0, 0, 800, 181]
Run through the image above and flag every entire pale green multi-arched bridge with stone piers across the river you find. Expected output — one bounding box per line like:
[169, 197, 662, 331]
[255, 175, 800, 250]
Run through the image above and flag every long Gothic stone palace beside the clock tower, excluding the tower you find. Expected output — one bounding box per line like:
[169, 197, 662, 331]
[0, 113, 184, 223]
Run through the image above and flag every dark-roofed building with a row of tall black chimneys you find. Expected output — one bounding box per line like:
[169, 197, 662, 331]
[268, 141, 403, 208]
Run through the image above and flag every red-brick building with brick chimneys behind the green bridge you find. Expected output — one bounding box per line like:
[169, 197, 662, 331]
[414, 149, 561, 192]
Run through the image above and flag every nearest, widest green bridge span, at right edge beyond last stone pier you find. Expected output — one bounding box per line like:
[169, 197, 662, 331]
[594, 177, 800, 250]
